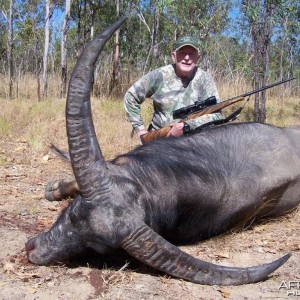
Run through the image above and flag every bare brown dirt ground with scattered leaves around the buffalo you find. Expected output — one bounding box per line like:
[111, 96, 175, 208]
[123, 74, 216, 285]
[0, 140, 300, 300]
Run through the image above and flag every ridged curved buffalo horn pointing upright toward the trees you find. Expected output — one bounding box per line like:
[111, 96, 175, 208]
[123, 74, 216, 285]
[66, 17, 127, 200]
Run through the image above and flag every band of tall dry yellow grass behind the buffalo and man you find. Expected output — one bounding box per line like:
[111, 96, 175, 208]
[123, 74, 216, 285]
[0, 76, 300, 159]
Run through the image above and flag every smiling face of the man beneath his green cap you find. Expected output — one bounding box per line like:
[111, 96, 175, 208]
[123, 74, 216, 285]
[172, 46, 199, 78]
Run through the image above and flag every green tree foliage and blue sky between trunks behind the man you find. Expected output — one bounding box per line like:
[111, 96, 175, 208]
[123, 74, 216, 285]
[0, 0, 300, 94]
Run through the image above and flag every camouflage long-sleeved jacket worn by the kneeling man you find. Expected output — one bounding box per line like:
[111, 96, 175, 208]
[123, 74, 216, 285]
[124, 65, 223, 132]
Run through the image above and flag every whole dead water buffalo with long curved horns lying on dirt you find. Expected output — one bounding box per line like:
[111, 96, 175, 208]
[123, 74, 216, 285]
[26, 18, 300, 285]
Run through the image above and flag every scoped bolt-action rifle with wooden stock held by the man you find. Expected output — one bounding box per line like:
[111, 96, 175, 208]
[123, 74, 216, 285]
[141, 77, 295, 144]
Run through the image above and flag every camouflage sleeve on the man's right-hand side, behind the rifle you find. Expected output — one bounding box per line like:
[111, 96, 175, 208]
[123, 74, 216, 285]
[186, 75, 224, 130]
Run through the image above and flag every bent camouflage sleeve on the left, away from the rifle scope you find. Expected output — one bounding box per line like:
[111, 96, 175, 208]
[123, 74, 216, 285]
[124, 70, 159, 132]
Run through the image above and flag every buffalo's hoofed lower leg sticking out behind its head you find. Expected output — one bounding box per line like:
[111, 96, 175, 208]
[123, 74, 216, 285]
[45, 179, 79, 201]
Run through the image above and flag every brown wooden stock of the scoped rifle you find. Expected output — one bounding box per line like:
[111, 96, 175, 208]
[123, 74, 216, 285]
[141, 97, 245, 144]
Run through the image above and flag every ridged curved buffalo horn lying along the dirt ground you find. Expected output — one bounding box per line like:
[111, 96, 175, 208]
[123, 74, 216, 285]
[122, 225, 291, 285]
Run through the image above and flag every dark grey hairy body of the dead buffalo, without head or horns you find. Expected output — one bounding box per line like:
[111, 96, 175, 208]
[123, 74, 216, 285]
[110, 123, 300, 242]
